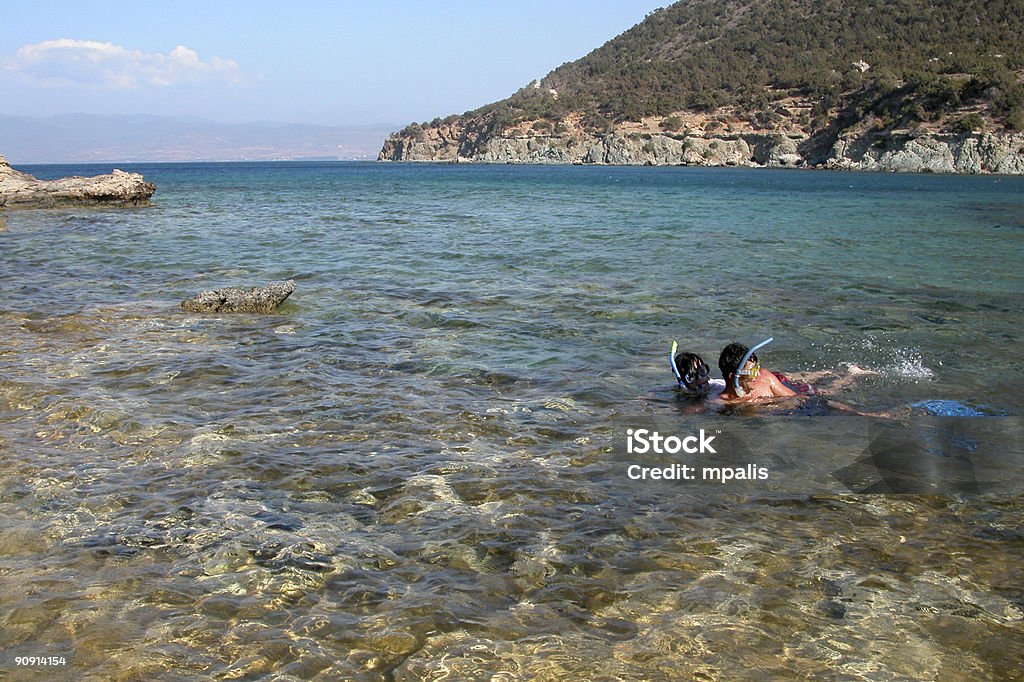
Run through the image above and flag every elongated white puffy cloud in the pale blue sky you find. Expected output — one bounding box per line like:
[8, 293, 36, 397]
[5, 38, 242, 89]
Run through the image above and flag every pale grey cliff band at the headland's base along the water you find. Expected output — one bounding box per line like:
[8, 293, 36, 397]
[379, 125, 1024, 174]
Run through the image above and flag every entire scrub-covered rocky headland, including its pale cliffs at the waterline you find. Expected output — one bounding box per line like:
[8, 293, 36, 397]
[379, 0, 1024, 173]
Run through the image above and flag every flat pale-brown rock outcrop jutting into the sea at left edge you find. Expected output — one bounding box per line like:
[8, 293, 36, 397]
[0, 156, 157, 209]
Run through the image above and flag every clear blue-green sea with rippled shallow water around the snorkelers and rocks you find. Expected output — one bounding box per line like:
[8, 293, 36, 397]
[0, 162, 1024, 681]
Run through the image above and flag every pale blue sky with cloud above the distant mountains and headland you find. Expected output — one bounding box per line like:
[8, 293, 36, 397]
[0, 0, 670, 126]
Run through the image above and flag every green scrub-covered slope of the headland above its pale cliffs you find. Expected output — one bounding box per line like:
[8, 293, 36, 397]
[396, 0, 1024, 143]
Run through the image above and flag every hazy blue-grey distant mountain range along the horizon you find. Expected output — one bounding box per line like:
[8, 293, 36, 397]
[0, 114, 397, 165]
